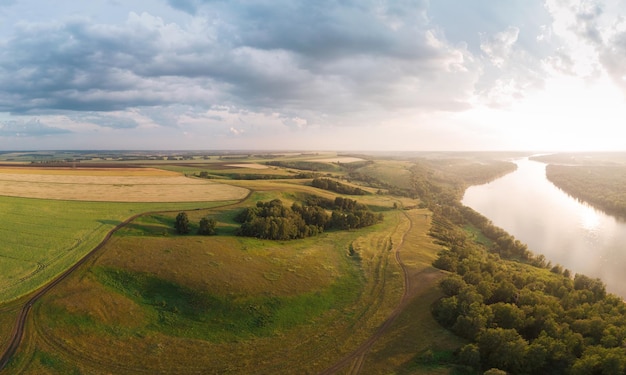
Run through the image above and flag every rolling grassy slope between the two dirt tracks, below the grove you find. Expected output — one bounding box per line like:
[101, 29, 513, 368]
[3, 191, 448, 373]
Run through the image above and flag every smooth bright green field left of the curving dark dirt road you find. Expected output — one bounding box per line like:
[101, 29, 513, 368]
[0, 196, 239, 302]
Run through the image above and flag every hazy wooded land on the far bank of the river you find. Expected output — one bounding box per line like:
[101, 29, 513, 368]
[546, 164, 626, 218]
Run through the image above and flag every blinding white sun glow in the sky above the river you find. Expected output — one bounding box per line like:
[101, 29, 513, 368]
[458, 75, 626, 151]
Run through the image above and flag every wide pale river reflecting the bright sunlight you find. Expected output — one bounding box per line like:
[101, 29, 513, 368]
[462, 159, 626, 298]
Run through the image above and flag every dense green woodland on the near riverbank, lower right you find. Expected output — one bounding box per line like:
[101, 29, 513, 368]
[433, 216, 626, 374]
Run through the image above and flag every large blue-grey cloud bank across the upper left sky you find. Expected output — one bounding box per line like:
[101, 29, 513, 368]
[0, 0, 476, 125]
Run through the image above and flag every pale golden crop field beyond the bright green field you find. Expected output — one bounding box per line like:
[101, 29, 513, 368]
[0, 168, 248, 202]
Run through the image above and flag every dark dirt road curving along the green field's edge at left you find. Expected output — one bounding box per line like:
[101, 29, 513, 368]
[0, 194, 253, 371]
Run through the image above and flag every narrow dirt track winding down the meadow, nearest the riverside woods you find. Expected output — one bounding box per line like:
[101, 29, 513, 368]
[320, 211, 413, 375]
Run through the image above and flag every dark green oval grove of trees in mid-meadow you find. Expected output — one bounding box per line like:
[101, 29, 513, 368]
[235, 197, 383, 240]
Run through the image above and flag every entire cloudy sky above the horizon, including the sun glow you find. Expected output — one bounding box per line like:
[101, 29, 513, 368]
[0, 0, 626, 151]
